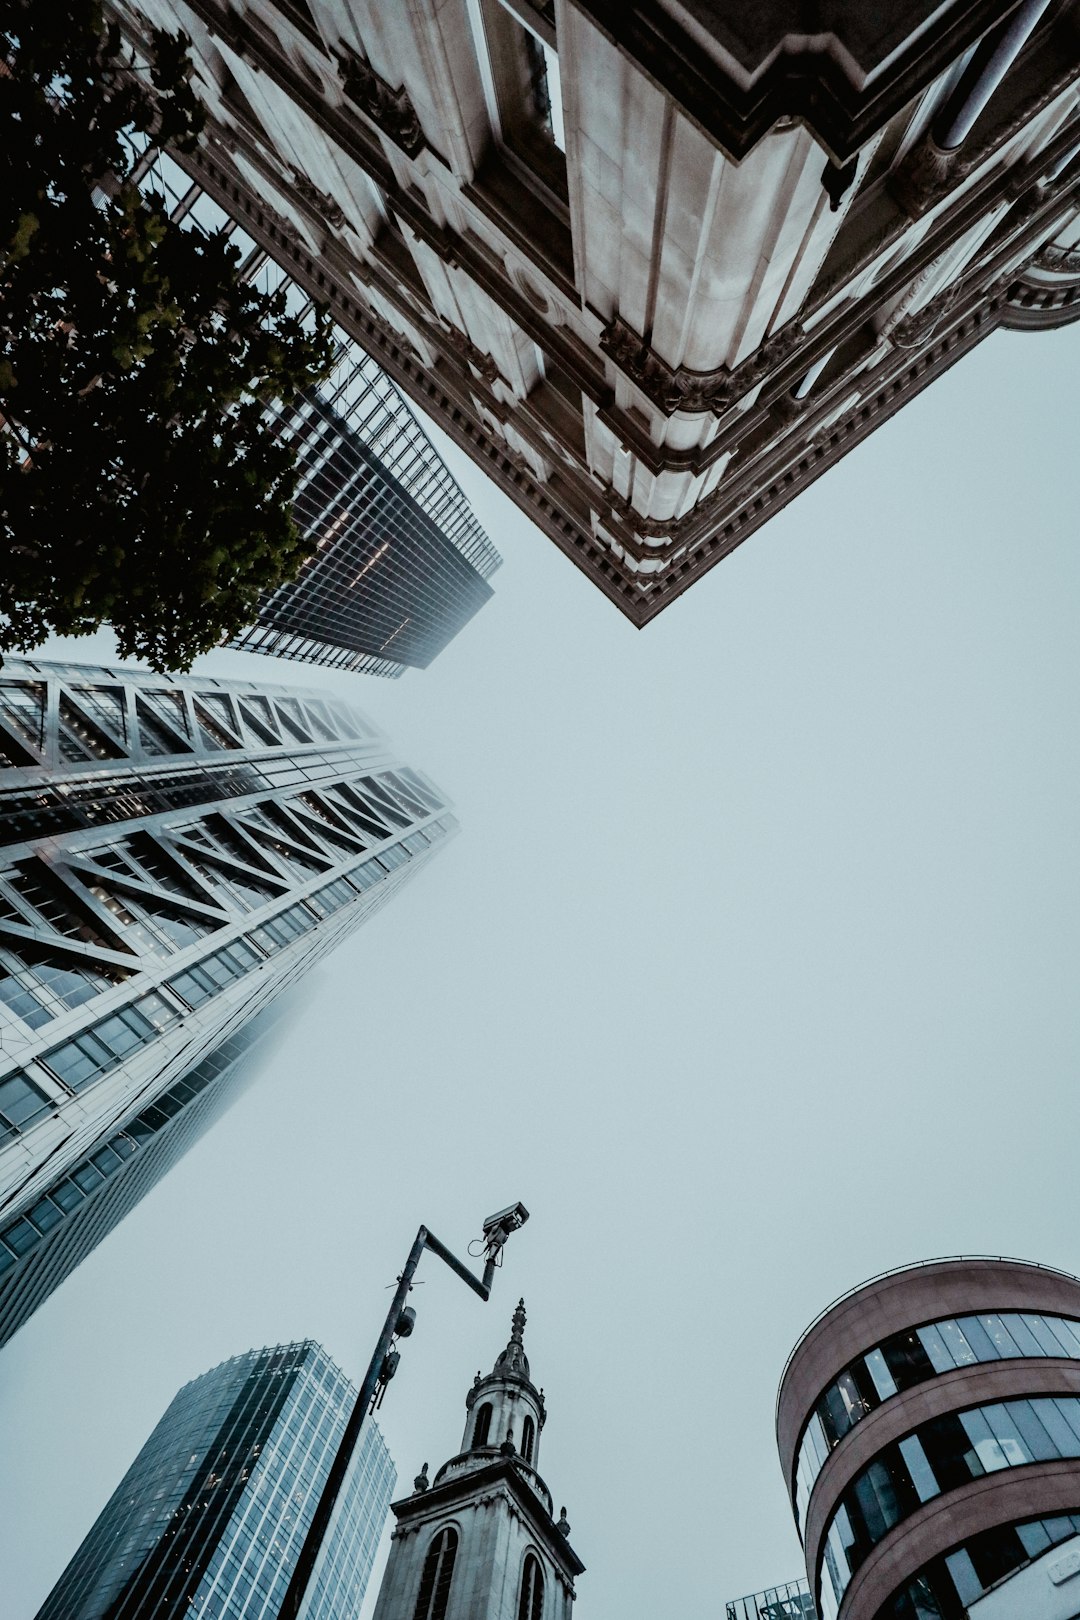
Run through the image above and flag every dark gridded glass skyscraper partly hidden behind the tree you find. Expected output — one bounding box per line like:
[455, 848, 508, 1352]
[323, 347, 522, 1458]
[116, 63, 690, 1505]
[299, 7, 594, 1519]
[124, 136, 502, 677]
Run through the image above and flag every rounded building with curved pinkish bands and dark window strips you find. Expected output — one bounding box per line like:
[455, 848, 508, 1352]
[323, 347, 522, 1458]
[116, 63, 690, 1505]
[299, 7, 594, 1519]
[777, 1260, 1080, 1620]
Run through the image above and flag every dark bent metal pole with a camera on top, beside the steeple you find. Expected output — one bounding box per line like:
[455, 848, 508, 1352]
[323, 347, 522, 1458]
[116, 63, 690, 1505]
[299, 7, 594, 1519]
[279, 1204, 529, 1620]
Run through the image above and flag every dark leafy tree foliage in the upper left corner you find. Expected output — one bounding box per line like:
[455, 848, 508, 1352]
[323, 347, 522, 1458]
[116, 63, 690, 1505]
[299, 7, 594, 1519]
[0, 0, 330, 669]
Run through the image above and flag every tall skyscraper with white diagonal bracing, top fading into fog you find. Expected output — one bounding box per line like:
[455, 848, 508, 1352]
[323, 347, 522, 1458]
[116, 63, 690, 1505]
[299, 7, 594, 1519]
[0, 661, 457, 1343]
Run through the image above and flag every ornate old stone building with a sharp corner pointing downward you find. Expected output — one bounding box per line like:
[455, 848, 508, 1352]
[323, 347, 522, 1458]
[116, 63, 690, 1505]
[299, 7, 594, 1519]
[112, 0, 1080, 625]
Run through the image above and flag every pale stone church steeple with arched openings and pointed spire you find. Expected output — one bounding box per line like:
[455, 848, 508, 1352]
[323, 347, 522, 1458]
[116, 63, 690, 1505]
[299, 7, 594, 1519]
[367, 1299, 585, 1620]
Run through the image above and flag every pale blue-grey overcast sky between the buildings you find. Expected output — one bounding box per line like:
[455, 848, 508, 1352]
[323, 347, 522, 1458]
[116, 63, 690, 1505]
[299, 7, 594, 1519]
[0, 319, 1080, 1620]
